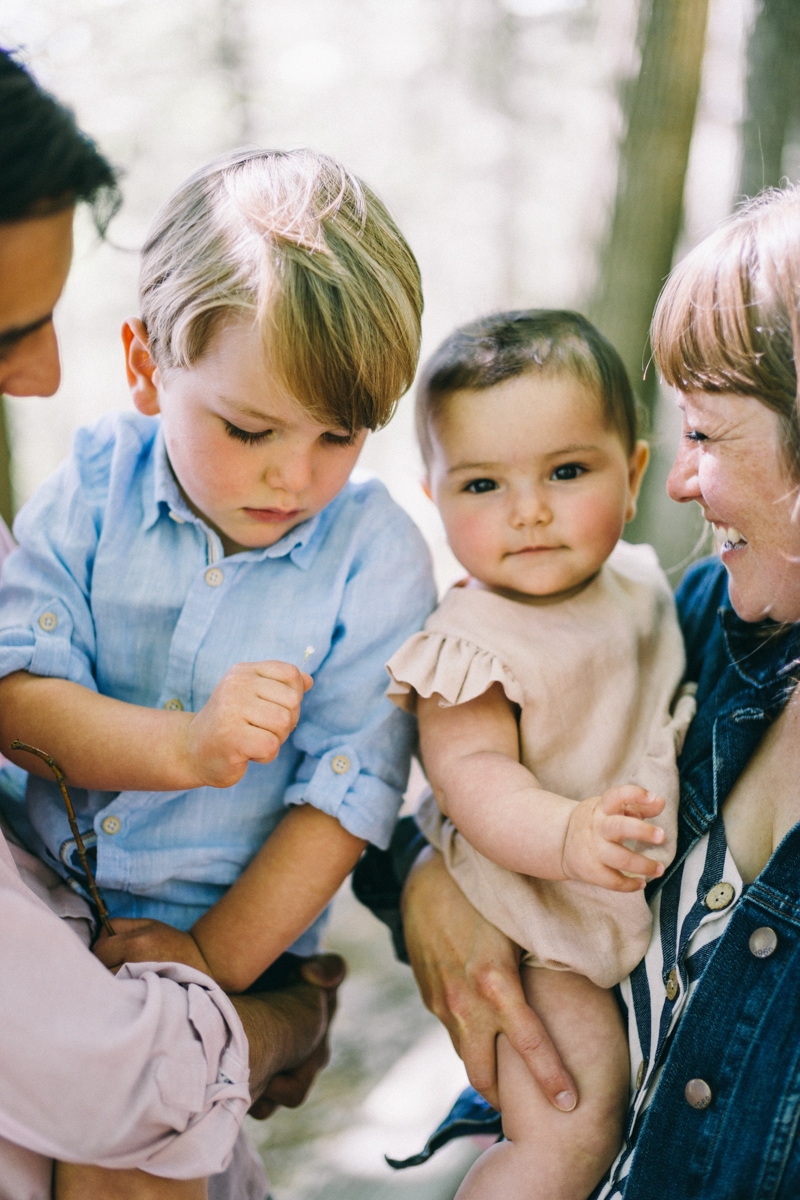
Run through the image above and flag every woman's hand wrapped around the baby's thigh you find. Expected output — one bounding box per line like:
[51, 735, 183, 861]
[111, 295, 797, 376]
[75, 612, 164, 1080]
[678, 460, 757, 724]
[402, 850, 578, 1112]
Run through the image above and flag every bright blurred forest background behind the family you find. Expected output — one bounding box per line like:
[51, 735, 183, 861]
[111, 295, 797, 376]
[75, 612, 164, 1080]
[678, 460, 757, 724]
[0, 0, 800, 1200]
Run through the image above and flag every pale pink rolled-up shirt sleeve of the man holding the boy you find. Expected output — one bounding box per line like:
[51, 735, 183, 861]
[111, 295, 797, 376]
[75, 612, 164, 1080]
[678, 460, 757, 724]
[0, 835, 249, 1176]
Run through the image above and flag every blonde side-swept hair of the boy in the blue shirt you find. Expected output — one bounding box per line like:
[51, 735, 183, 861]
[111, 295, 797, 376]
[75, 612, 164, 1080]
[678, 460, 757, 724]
[139, 150, 422, 432]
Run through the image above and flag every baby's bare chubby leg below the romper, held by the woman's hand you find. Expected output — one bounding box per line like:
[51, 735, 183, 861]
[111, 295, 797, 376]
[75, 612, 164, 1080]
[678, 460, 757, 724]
[456, 967, 628, 1200]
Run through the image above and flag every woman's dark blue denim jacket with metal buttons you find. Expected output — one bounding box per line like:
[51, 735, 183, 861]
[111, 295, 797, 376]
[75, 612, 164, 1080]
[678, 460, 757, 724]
[354, 560, 800, 1200]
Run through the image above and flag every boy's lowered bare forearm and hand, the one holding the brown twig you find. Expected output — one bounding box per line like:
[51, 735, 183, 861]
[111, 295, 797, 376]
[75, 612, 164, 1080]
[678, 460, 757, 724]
[95, 804, 366, 992]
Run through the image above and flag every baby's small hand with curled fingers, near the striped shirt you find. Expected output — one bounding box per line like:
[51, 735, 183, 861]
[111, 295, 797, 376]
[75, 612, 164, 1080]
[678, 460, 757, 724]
[561, 785, 664, 892]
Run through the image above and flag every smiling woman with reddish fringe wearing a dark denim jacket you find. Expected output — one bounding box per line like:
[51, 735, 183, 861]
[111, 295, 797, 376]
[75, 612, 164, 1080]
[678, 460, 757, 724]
[360, 187, 800, 1200]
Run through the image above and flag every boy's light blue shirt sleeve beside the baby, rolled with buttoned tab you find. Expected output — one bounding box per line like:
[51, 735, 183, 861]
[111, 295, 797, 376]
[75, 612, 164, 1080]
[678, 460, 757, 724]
[285, 492, 435, 847]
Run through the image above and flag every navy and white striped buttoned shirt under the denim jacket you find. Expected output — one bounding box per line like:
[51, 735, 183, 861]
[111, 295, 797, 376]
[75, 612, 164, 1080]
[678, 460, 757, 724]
[596, 816, 744, 1200]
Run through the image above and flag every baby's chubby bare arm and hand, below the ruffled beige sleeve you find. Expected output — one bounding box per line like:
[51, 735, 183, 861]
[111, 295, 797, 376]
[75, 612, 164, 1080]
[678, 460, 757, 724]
[417, 683, 664, 892]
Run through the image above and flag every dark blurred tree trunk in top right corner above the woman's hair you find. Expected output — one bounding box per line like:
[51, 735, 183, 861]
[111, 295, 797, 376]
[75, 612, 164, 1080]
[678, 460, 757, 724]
[739, 0, 800, 196]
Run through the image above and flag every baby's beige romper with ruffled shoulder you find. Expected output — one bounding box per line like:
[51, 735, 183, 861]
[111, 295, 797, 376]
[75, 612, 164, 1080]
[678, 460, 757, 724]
[387, 541, 694, 988]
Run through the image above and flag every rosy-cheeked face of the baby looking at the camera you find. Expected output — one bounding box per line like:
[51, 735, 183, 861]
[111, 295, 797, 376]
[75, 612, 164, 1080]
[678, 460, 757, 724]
[429, 373, 648, 596]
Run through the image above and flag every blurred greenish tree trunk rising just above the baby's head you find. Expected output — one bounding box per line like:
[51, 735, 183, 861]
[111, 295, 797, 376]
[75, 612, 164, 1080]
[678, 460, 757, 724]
[590, 0, 708, 409]
